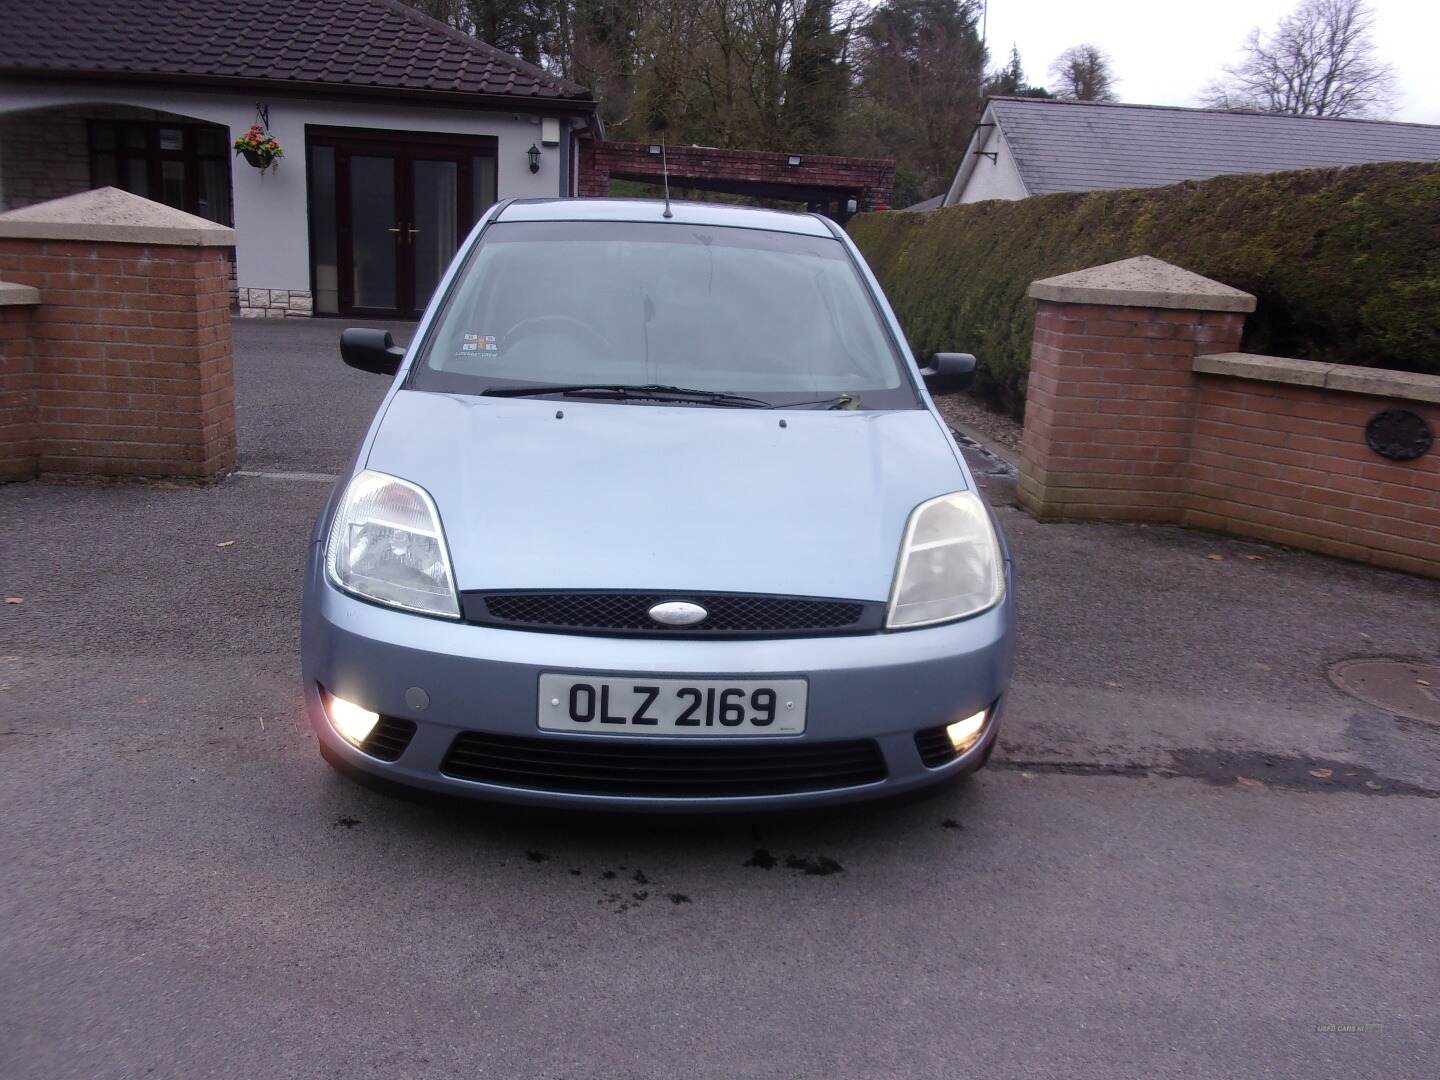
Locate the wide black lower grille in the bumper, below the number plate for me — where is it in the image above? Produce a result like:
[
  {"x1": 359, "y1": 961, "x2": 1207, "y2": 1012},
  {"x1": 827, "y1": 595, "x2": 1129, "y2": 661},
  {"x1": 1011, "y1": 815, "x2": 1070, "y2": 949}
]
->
[{"x1": 441, "y1": 732, "x2": 886, "y2": 799}]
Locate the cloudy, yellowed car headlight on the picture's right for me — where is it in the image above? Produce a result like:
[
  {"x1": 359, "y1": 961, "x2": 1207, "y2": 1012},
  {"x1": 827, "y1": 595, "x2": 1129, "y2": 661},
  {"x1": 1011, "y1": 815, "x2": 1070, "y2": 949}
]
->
[{"x1": 886, "y1": 491, "x2": 1005, "y2": 629}]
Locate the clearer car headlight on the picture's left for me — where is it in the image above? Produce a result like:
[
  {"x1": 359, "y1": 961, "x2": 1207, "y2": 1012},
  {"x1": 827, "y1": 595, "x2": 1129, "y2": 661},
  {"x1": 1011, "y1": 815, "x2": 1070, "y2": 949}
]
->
[{"x1": 325, "y1": 471, "x2": 459, "y2": 619}]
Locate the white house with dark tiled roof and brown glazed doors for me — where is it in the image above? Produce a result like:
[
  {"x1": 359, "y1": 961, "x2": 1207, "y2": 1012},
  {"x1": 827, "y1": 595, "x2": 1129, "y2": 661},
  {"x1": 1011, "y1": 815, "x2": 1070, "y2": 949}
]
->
[{"x1": 0, "y1": 0, "x2": 603, "y2": 317}]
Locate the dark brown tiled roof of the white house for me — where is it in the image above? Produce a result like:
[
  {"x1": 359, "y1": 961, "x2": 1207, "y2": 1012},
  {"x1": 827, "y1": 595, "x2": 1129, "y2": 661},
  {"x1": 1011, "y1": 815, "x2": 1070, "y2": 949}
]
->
[{"x1": 0, "y1": 0, "x2": 590, "y2": 101}]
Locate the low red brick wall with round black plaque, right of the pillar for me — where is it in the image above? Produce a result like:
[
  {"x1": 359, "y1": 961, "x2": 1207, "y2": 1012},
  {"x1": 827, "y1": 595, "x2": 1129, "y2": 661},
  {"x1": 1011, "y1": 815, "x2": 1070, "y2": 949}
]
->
[{"x1": 1182, "y1": 374, "x2": 1440, "y2": 577}]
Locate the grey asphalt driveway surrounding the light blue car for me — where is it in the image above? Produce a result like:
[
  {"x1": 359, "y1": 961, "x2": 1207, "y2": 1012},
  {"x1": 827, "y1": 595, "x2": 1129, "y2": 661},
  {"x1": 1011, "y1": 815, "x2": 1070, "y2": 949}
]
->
[{"x1": 0, "y1": 320, "x2": 1440, "y2": 1080}]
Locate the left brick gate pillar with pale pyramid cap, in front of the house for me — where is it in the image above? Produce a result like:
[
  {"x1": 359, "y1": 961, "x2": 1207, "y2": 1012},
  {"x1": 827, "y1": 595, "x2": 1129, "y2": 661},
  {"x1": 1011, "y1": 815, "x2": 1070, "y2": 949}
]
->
[{"x1": 0, "y1": 189, "x2": 235, "y2": 478}]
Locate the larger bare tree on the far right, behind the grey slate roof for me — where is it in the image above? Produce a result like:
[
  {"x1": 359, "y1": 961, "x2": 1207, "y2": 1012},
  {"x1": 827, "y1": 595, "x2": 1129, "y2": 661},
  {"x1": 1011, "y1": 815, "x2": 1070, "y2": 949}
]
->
[{"x1": 1200, "y1": 0, "x2": 1395, "y2": 117}]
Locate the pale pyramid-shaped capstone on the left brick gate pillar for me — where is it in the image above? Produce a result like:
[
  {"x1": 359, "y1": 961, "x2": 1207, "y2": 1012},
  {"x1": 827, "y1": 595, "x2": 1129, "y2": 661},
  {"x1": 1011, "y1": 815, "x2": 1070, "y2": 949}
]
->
[{"x1": 0, "y1": 187, "x2": 235, "y2": 248}]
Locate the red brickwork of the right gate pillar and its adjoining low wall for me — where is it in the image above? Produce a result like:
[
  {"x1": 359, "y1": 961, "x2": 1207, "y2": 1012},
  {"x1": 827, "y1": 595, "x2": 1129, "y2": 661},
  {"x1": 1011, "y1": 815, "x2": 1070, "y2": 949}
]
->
[{"x1": 1018, "y1": 292, "x2": 1440, "y2": 577}]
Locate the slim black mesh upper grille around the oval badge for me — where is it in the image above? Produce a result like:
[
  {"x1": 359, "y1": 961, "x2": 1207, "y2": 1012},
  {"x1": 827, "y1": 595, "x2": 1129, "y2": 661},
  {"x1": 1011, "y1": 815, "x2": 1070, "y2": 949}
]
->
[{"x1": 462, "y1": 592, "x2": 884, "y2": 638}]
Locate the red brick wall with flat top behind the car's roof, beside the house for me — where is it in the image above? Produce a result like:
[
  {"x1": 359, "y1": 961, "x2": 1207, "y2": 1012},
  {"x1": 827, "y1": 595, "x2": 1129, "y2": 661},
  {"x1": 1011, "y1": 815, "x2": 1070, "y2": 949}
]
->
[{"x1": 579, "y1": 141, "x2": 896, "y2": 210}]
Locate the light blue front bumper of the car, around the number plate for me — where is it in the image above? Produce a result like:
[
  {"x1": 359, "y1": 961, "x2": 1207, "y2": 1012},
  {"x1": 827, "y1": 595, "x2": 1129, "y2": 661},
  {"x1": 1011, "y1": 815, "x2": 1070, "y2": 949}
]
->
[{"x1": 302, "y1": 544, "x2": 1014, "y2": 812}]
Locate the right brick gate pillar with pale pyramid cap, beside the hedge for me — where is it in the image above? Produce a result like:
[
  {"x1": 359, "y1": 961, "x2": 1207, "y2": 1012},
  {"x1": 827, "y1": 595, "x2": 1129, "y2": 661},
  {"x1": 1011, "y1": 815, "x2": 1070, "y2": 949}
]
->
[{"x1": 1017, "y1": 256, "x2": 1254, "y2": 521}]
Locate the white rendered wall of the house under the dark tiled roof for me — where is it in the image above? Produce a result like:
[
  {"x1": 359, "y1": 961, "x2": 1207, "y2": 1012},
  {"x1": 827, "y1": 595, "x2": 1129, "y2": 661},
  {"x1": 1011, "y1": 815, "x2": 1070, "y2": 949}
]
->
[{"x1": 0, "y1": 82, "x2": 577, "y2": 291}]
